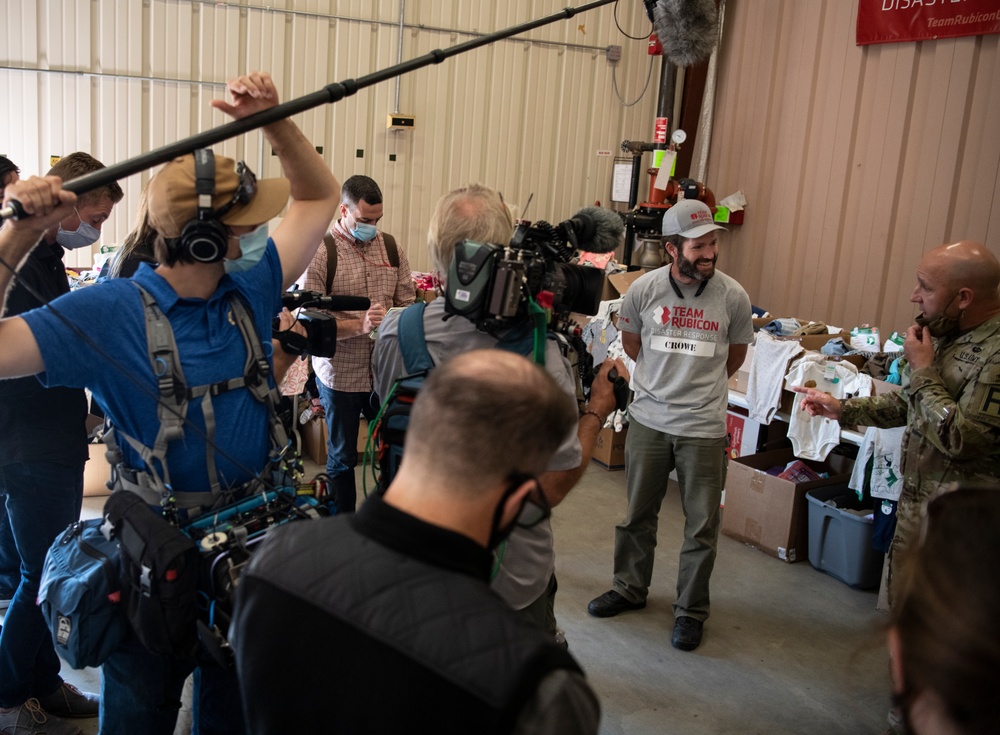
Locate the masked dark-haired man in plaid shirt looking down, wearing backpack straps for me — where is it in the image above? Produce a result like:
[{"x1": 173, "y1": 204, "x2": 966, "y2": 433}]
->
[{"x1": 305, "y1": 175, "x2": 414, "y2": 513}]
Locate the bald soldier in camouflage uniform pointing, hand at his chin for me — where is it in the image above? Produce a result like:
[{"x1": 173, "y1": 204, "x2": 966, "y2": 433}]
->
[{"x1": 795, "y1": 241, "x2": 1000, "y2": 605}]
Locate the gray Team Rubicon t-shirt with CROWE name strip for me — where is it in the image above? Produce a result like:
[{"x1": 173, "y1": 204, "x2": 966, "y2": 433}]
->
[{"x1": 618, "y1": 268, "x2": 753, "y2": 439}]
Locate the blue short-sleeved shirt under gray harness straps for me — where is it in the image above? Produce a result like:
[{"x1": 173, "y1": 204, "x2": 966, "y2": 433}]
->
[{"x1": 23, "y1": 240, "x2": 281, "y2": 492}]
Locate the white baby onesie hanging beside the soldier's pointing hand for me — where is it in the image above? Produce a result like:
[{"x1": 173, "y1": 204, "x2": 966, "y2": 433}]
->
[{"x1": 784, "y1": 352, "x2": 871, "y2": 461}]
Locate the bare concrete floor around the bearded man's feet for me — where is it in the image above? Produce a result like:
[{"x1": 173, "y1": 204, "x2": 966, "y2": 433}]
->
[{"x1": 11, "y1": 463, "x2": 889, "y2": 735}]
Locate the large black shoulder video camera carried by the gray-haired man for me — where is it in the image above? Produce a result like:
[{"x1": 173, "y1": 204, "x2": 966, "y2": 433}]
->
[{"x1": 445, "y1": 207, "x2": 624, "y2": 333}]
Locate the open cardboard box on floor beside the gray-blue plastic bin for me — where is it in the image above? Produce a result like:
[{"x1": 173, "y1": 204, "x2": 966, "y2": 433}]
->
[{"x1": 722, "y1": 448, "x2": 854, "y2": 564}]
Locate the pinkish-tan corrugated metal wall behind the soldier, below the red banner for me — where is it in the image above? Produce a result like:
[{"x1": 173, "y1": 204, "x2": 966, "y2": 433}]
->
[{"x1": 706, "y1": 0, "x2": 1000, "y2": 332}]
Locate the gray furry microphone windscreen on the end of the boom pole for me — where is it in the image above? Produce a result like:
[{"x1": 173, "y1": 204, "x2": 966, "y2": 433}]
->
[{"x1": 653, "y1": 0, "x2": 719, "y2": 66}]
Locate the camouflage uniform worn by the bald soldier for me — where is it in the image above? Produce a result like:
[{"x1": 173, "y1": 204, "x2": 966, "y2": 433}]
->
[{"x1": 840, "y1": 317, "x2": 1000, "y2": 604}]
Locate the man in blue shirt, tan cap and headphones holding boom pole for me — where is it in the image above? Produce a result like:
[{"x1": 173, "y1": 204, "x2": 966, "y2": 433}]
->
[{"x1": 0, "y1": 72, "x2": 339, "y2": 735}]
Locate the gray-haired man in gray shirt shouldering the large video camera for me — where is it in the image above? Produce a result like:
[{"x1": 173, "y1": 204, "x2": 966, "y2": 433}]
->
[{"x1": 372, "y1": 184, "x2": 628, "y2": 639}]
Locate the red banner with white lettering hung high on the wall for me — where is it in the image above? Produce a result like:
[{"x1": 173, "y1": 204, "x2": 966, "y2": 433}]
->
[{"x1": 858, "y1": 0, "x2": 1000, "y2": 46}]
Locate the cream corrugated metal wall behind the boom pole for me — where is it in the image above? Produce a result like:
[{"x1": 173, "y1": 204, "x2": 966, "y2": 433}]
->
[{"x1": 0, "y1": 0, "x2": 658, "y2": 270}]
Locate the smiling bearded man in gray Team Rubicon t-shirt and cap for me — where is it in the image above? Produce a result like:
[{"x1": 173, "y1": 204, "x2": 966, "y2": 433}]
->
[{"x1": 587, "y1": 199, "x2": 753, "y2": 651}]
